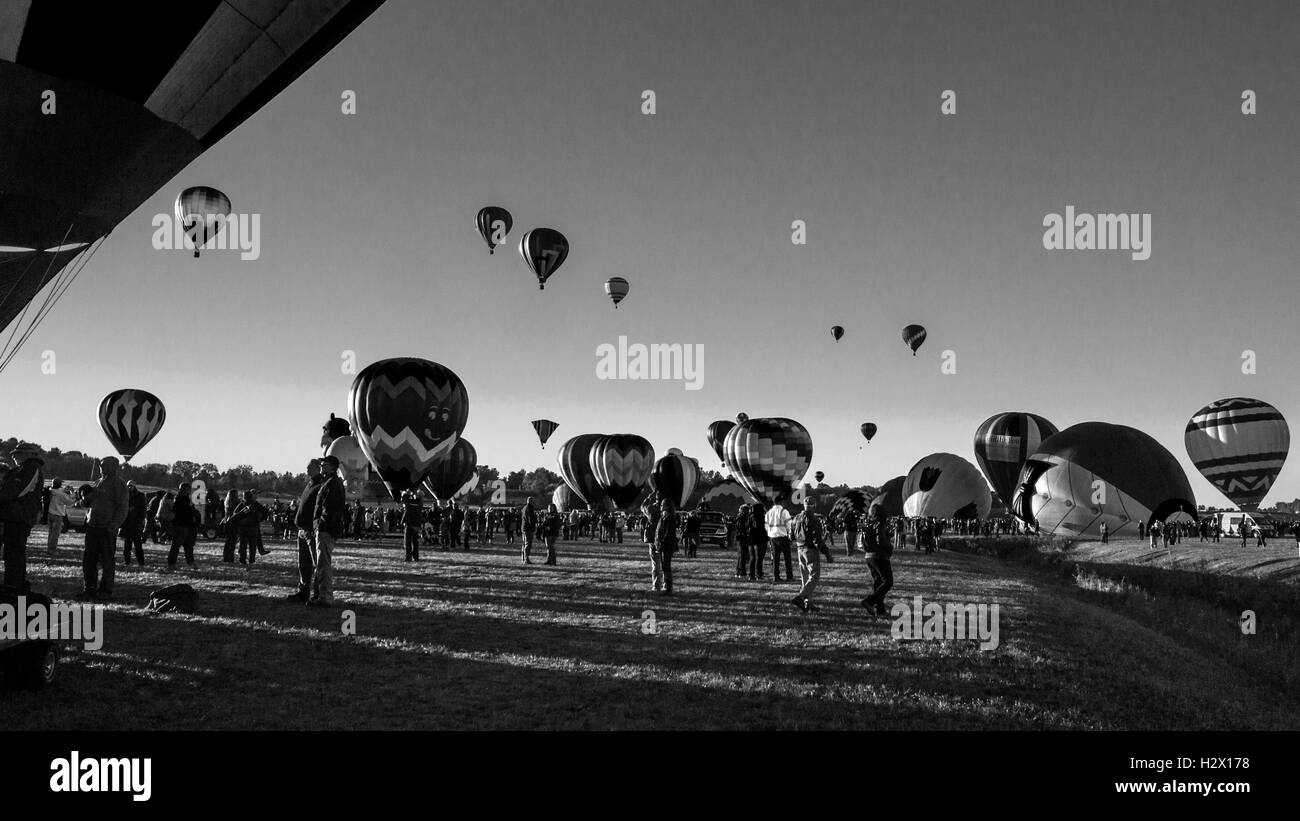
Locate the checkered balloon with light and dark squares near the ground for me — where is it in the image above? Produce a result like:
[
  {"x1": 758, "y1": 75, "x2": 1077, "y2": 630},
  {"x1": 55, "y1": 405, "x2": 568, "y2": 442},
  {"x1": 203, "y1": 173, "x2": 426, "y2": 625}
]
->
[{"x1": 723, "y1": 418, "x2": 813, "y2": 504}]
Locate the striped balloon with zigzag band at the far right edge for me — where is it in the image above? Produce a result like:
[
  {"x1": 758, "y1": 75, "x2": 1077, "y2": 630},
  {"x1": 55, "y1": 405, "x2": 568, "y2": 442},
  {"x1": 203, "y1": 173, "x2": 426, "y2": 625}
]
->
[{"x1": 1183, "y1": 396, "x2": 1291, "y2": 511}]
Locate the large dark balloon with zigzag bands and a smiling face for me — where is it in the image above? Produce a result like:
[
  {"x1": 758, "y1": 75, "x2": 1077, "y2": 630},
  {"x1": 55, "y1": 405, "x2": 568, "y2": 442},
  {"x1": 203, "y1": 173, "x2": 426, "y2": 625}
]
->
[{"x1": 347, "y1": 359, "x2": 469, "y2": 499}]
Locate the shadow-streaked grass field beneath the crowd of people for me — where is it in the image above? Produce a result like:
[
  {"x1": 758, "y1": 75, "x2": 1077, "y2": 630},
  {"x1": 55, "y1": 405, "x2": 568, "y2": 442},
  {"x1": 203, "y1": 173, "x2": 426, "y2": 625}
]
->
[{"x1": 0, "y1": 527, "x2": 1300, "y2": 730}]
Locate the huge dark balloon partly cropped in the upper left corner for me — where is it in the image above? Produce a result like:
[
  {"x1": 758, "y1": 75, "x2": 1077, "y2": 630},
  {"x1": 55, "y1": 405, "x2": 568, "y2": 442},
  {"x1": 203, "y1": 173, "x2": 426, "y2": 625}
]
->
[{"x1": 0, "y1": 0, "x2": 378, "y2": 366}]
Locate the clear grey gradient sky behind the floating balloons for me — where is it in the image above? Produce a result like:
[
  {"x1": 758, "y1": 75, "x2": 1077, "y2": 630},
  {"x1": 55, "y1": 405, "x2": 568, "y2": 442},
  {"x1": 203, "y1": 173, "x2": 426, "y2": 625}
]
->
[{"x1": 0, "y1": 0, "x2": 1300, "y2": 504}]
